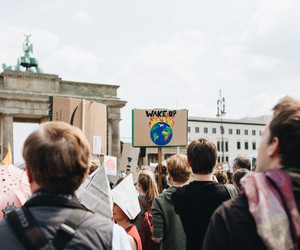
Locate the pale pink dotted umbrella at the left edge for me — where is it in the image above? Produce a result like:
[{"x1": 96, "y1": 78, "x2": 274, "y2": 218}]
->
[{"x1": 0, "y1": 164, "x2": 31, "y2": 219}]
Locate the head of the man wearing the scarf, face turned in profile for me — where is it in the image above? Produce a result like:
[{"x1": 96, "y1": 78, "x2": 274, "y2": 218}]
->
[{"x1": 256, "y1": 97, "x2": 300, "y2": 172}]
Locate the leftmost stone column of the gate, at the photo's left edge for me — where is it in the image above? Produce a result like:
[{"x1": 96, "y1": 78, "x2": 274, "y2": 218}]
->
[{"x1": 2, "y1": 115, "x2": 14, "y2": 162}]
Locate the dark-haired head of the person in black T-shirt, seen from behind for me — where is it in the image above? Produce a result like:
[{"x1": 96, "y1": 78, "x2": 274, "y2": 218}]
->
[{"x1": 187, "y1": 138, "x2": 217, "y2": 174}]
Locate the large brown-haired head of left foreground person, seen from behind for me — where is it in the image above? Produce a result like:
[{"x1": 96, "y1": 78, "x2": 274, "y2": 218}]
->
[{"x1": 23, "y1": 122, "x2": 91, "y2": 193}]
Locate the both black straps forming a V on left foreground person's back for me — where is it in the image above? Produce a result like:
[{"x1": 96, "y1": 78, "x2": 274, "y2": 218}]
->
[{"x1": 7, "y1": 207, "x2": 87, "y2": 250}]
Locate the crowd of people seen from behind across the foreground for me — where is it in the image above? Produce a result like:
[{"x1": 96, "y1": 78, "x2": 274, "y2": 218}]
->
[{"x1": 0, "y1": 97, "x2": 300, "y2": 250}]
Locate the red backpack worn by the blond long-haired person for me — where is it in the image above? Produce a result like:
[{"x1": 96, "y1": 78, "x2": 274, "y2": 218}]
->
[{"x1": 139, "y1": 199, "x2": 160, "y2": 250}]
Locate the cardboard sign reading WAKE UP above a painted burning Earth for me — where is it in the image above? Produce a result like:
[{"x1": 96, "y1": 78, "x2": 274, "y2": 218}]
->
[{"x1": 132, "y1": 109, "x2": 188, "y2": 147}]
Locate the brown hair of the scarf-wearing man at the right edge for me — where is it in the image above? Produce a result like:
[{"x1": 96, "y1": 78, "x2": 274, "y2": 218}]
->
[{"x1": 269, "y1": 97, "x2": 300, "y2": 167}]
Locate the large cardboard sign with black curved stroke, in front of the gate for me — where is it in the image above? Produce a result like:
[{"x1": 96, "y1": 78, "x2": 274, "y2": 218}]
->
[{"x1": 52, "y1": 96, "x2": 107, "y2": 154}]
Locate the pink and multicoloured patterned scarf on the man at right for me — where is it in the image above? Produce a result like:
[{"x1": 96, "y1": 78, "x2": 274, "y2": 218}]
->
[{"x1": 241, "y1": 169, "x2": 300, "y2": 249}]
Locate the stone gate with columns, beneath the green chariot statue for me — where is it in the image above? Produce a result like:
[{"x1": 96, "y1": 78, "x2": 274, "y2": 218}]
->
[{"x1": 0, "y1": 70, "x2": 126, "y2": 164}]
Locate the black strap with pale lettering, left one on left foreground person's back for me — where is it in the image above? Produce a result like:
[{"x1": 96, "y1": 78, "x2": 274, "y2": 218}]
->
[{"x1": 6, "y1": 207, "x2": 48, "y2": 250}]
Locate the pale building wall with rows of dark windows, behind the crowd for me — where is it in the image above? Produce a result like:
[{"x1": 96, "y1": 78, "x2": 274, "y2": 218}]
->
[{"x1": 188, "y1": 116, "x2": 268, "y2": 165}]
